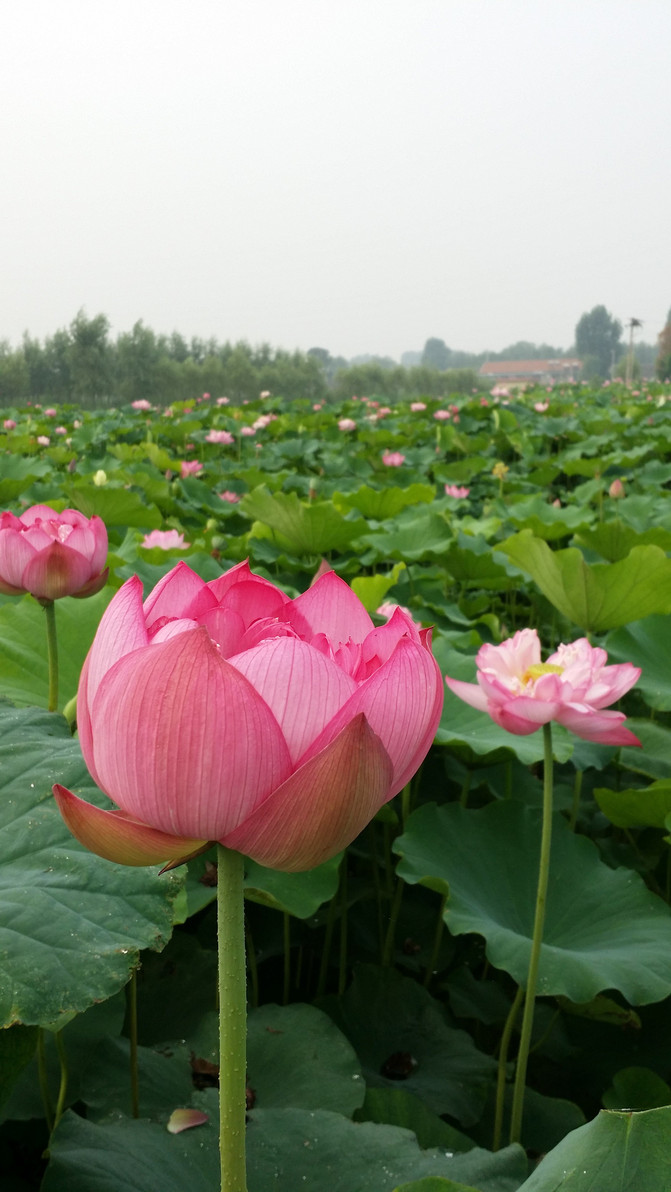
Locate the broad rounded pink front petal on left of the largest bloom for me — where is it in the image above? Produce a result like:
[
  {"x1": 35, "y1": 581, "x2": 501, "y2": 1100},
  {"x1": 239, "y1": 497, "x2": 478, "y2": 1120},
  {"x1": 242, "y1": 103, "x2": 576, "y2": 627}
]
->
[{"x1": 91, "y1": 628, "x2": 291, "y2": 840}]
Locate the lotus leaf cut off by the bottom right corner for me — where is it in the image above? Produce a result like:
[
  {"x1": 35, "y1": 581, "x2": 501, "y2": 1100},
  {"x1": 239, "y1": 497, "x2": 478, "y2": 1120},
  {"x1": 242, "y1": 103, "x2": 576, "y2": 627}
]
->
[{"x1": 520, "y1": 1105, "x2": 671, "y2": 1192}]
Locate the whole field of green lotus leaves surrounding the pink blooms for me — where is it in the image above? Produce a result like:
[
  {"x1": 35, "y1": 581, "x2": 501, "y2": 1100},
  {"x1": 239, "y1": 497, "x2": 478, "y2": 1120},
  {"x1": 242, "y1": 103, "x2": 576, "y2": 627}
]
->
[{"x1": 0, "y1": 384, "x2": 671, "y2": 1192}]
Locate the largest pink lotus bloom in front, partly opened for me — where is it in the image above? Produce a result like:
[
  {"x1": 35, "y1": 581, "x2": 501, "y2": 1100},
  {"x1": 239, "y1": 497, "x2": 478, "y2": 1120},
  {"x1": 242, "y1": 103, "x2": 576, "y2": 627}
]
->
[{"x1": 54, "y1": 563, "x2": 445, "y2": 871}]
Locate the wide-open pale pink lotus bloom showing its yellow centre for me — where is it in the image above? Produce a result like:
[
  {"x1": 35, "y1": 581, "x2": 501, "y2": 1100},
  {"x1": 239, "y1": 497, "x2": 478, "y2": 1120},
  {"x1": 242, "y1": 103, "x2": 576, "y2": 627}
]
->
[{"x1": 446, "y1": 629, "x2": 641, "y2": 745}]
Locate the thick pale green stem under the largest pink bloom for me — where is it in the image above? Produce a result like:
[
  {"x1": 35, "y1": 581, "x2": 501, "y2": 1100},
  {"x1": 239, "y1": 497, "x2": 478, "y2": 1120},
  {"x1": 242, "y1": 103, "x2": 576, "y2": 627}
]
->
[{"x1": 217, "y1": 844, "x2": 247, "y2": 1192}]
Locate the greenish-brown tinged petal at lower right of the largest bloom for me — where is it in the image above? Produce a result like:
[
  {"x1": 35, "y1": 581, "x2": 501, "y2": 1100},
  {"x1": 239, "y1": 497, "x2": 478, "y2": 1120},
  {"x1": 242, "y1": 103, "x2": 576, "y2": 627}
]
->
[{"x1": 222, "y1": 714, "x2": 392, "y2": 873}]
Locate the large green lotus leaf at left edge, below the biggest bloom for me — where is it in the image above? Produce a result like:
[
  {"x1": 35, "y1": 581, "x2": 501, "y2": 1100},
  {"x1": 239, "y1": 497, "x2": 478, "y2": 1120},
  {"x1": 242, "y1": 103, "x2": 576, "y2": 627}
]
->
[{"x1": 0, "y1": 707, "x2": 181, "y2": 1025}]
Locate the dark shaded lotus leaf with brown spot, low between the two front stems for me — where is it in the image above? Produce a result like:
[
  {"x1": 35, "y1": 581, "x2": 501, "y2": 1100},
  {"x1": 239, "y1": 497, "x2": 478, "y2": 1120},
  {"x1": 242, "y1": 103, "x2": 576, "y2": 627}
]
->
[{"x1": 323, "y1": 964, "x2": 495, "y2": 1126}]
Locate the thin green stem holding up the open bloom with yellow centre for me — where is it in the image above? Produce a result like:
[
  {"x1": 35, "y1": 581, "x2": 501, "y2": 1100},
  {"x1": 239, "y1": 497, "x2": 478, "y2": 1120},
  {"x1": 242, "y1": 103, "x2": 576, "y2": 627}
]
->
[{"x1": 510, "y1": 722, "x2": 553, "y2": 1142}]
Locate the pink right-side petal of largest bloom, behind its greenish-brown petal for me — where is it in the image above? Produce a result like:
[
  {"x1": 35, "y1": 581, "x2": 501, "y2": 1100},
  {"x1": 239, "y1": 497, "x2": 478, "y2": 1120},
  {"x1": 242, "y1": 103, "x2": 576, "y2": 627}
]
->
[{"x1": 302, "y1": 638, "x2": 443, "y2": 799}]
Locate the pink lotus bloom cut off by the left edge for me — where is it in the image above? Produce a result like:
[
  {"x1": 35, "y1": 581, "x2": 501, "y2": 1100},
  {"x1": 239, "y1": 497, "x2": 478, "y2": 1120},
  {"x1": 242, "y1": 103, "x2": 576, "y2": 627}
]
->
[{"x1": 0, "y1": 505, "x2": 107, "y2": 601}]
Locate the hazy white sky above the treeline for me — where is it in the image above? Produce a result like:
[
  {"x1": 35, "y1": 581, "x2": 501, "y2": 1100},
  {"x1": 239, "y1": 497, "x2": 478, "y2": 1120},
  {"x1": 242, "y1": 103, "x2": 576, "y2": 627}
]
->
[{"x1": 0, "y1": 0, "x2": 671, "y2": 358}]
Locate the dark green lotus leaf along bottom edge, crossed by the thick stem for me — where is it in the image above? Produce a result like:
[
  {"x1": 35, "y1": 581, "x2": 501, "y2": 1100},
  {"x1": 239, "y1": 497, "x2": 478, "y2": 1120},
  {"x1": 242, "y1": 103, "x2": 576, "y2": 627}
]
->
[{"x1": 42, "y1": 1098, "x2": 527, "y2": 1192}]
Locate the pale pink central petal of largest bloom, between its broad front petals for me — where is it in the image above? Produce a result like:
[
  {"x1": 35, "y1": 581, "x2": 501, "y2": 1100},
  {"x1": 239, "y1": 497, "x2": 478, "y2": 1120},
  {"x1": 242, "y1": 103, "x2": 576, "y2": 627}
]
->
[{"x1": 229, "y1": 637, "x2": 356, "y2": 764}]
